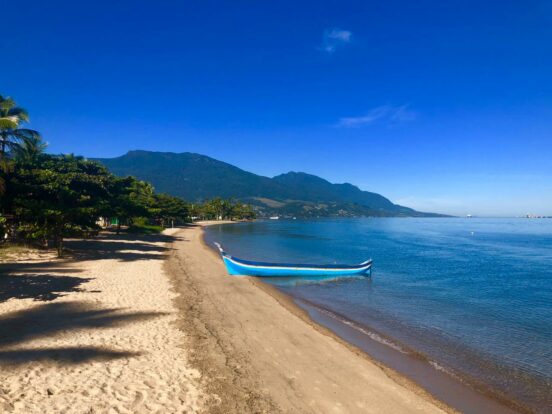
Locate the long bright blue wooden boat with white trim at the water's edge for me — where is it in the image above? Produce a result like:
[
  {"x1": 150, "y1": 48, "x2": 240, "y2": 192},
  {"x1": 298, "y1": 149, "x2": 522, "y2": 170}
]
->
[{"x1": 215, "y1": 243, "x2": 372, "y2": 277}]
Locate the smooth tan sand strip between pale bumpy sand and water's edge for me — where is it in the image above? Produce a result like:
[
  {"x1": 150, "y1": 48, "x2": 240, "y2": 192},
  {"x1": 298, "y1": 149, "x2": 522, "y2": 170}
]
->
[{"x1": 165, "y1": 223, "x2": 450, "y2": 413}]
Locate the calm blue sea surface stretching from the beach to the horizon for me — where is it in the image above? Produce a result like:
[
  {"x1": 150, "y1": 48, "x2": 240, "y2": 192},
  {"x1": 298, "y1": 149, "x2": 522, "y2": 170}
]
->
[{"x1": 206, "y1": 218, "x2": 552, "y2": 412}]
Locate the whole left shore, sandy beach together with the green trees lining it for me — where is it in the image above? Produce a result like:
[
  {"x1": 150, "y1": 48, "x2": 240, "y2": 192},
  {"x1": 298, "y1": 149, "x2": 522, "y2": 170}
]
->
[{"x1": 0, "y1": 94, "x2": 443, "y2": 414}]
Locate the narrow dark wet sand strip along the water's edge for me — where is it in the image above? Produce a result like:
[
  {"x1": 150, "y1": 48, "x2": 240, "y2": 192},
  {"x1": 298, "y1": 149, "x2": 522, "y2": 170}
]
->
[{"x1": 198, "y1": 222, "x2": 532, "y2": 414}]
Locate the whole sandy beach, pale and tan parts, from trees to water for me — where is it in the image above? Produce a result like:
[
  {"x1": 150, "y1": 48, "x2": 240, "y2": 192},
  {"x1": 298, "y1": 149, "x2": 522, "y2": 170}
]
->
[{"x1": 0, "y1": 226, "x2": 450, "y2": 413}]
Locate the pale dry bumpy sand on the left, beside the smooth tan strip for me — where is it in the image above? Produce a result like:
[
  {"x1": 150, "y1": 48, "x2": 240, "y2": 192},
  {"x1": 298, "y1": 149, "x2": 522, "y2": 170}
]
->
[{"x1": 0, "y1": 231, "x2": 202, "y2": 414}]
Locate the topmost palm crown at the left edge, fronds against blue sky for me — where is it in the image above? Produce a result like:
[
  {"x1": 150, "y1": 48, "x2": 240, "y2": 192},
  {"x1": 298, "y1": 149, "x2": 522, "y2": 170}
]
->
[{"x1": 0, "y1": 95, "x2": 40, "y2": 158}]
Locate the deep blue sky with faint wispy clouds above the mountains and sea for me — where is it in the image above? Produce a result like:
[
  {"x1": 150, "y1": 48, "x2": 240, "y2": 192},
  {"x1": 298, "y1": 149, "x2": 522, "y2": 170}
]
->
[{"x1": 4, "y1": 0, "x2": 552, "y2": 215}]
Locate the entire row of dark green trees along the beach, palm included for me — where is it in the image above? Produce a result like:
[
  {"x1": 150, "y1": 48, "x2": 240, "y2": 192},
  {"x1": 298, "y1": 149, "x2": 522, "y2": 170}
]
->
[{"x1": 0, "y1": 96, "x2": 255, "y2": 256}]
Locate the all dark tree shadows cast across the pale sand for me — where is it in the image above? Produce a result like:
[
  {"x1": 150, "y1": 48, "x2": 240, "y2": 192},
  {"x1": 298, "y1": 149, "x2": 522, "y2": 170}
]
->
[{"x1": 0, "y1": 233, "x2": 187, "y2": 371}]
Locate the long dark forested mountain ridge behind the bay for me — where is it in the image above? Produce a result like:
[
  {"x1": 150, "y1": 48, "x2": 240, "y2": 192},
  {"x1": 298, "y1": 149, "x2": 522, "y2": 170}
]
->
[{"x1": 96, "y1": 151, "x2": 439, "y2": 217}]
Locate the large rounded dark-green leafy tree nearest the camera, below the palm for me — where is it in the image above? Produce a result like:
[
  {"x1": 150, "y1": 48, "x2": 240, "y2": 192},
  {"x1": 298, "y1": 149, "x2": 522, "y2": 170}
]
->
[{"x1": 14, "y1": 155, "x2": 113, "y2": 256}]
